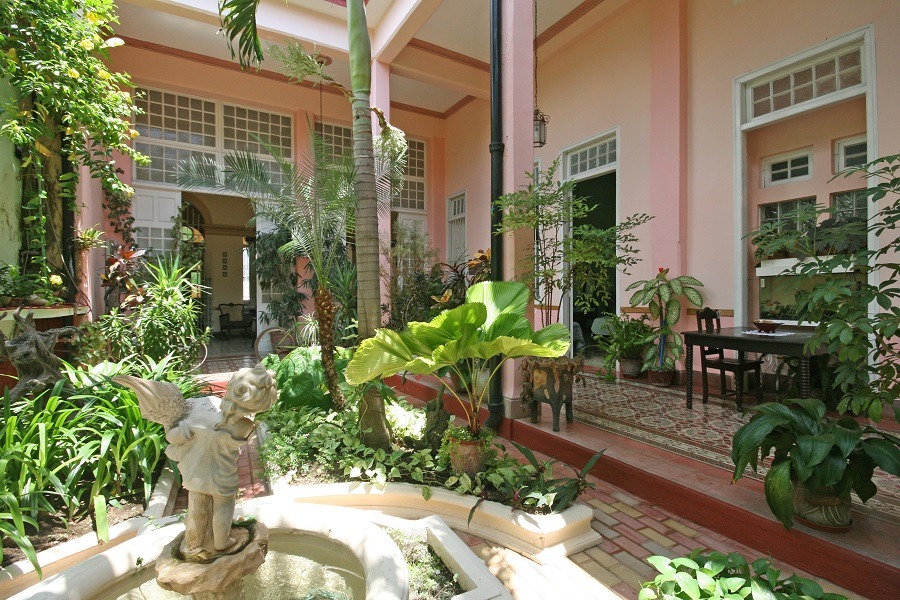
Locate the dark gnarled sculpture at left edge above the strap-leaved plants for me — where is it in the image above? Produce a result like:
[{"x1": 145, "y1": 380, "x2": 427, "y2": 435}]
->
[{"x1": 0, "y1": 307, "x2": 78, "y2": 402}]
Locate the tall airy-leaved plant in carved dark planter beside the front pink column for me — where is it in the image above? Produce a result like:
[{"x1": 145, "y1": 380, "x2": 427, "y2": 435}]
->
[{"x1": 498, "y1": 159, "x2": 651, "y2": 420}]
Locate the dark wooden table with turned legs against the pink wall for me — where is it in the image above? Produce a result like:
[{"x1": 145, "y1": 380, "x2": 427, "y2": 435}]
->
[{"x1": 681, "y1": 325, "x2": 827, "y2": 408}]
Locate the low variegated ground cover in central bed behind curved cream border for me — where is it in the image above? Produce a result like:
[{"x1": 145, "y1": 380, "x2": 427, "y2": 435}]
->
[{"x1": 261, "y1": 400, "x2": 602, "y2": 513}]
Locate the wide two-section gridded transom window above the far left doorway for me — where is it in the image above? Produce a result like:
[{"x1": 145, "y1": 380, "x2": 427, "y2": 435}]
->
[{"x1": 134, "y1": 89, "x2": 293, "y2": 185}]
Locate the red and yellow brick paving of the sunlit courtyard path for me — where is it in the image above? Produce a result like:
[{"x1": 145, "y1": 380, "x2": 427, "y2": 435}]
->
[{"x1": 195, "y1": 356, "x2": 865, "y2": 600}]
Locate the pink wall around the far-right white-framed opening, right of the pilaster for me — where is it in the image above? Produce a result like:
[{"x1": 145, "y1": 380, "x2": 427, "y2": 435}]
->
[{"x1": 687, "y1": 0, "x2": 900, "y2": 308}]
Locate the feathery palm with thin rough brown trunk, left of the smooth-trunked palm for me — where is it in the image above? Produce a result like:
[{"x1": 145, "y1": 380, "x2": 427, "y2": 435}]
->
[{"x1": 178, "y1": 135, "x2": 356, "y2": 408}]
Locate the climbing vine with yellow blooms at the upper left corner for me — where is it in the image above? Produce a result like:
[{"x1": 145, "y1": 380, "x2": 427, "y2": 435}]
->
[{"x1": 0, "y1": 0, "x2": 142, "y2": 282}]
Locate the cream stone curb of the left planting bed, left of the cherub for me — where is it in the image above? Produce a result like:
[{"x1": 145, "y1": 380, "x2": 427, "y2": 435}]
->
[{"x1": 0, "y1": 465, "x2": 179, "y2": 598}]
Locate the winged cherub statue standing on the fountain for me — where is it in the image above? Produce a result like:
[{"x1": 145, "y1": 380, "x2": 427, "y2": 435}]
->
[{"x1": 113, "y1": 364, "x2": 278, "y2": 562}]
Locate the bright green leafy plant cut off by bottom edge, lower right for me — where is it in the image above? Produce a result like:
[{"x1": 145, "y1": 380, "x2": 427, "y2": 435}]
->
[{"x1": 638, "y1": 548, "x2": 847, "y2": 600}]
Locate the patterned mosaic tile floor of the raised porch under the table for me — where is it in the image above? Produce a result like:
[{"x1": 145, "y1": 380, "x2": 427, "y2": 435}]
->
[{"x1": 574, "y1": 375, "x2": 900, "y2": 523}]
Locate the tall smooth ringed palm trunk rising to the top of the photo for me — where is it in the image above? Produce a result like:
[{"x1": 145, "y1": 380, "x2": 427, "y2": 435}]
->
[{"x1": 347, "y1": 0, "x2": 391, "y2": 449}]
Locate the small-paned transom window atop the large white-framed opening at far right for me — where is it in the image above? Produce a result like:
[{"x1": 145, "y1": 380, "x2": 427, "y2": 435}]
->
[{"x1": 748, "y1": 46, "x2": 863, "y2": 118}]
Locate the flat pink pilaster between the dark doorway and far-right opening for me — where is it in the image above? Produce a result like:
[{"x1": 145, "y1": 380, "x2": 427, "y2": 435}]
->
[{"x1": 650, "y1": 0, "x2": 687, "y2": 276}]
